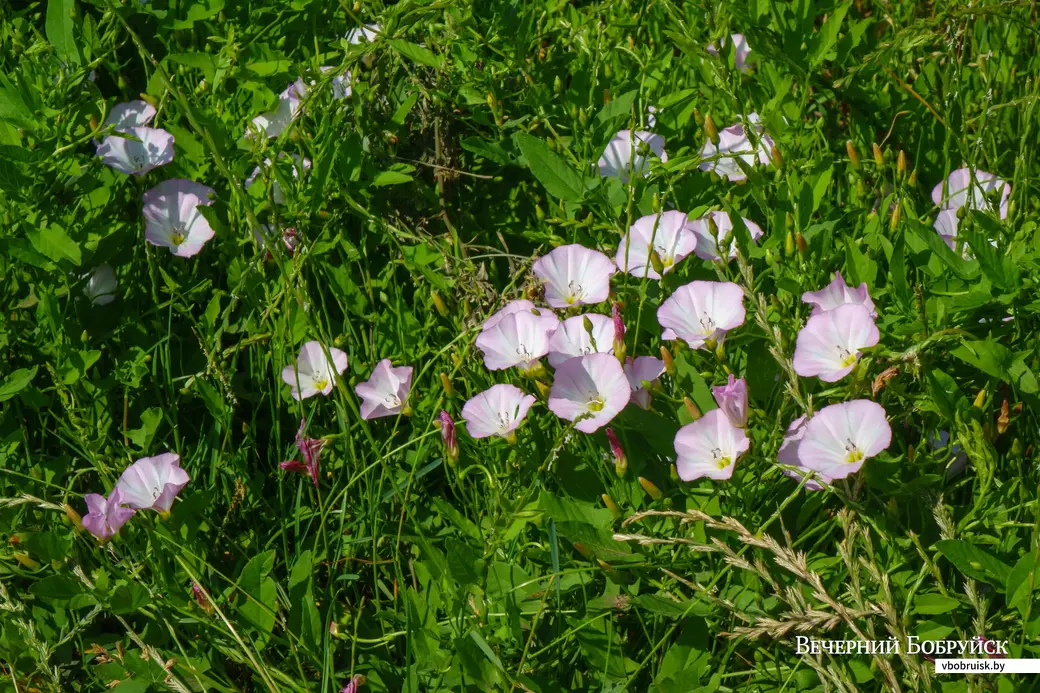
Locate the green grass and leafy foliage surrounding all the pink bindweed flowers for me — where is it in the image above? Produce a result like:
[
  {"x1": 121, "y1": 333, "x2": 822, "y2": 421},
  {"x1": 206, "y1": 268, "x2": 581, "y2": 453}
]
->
[{"x1": 0, "y1": 0, "x2": 1040, "y2": 693}]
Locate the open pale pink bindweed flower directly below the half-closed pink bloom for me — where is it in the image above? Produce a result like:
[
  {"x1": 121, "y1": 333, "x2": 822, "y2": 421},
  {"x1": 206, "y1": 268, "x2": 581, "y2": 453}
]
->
[{"x1": 675, "y1": 409, "x2": 751, "y2": 481}]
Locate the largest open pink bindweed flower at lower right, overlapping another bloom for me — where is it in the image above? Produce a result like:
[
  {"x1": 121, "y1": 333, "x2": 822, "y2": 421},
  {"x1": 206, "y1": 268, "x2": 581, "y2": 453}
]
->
[{"x1": 798, "y1": 400, "x2": 892, "y2": 479}]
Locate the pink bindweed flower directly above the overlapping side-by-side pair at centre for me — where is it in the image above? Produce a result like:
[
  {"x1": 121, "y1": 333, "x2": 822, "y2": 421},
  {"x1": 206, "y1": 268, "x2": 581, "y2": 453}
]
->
[{"x1": 531, "y1": 243, "x2": 618, "y2": 308}]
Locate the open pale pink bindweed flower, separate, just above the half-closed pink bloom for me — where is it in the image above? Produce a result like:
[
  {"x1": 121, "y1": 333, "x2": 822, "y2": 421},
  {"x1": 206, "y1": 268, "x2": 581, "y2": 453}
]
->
[{"x1": 657, "y1": 281, "x2": 746, "y2": 349}]
